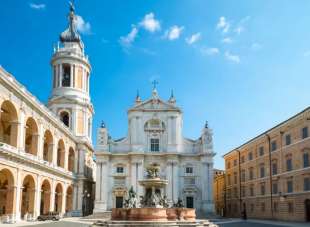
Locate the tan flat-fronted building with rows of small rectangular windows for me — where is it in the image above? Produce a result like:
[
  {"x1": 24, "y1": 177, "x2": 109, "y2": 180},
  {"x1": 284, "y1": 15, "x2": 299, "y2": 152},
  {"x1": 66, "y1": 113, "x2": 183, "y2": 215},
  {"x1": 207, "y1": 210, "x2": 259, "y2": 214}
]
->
[{"x1": 224, "y1": 107, "x2": 310, "y2": 221}]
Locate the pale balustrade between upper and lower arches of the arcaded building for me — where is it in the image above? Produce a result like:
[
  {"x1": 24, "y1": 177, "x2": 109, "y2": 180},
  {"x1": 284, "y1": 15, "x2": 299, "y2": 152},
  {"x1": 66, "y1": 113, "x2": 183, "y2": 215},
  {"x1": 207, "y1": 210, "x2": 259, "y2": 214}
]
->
[{"x1": 0, "y1": 142, "x2": 73, "y2": 176}]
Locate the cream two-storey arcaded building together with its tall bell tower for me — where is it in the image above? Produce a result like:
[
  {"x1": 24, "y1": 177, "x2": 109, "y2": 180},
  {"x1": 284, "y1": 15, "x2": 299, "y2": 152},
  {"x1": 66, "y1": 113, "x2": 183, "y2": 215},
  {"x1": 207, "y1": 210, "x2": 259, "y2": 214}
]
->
[{"x1": 0, "y1": 5, "x2": 95, "y2": 222}]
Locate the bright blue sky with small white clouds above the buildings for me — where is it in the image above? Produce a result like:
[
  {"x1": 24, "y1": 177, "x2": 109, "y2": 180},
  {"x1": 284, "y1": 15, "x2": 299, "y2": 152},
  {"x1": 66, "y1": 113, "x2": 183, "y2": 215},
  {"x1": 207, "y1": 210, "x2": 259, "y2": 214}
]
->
[{"x1": 0, "y1": 0, "x2": 310, "y2": 168}]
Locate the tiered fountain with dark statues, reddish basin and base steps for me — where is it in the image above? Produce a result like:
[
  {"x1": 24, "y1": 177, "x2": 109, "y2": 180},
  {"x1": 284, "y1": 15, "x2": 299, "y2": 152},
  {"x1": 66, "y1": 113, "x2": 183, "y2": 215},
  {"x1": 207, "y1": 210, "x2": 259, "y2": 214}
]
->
[{"x1": 94, "y1": 164, "x2": 214, "y2": 226}]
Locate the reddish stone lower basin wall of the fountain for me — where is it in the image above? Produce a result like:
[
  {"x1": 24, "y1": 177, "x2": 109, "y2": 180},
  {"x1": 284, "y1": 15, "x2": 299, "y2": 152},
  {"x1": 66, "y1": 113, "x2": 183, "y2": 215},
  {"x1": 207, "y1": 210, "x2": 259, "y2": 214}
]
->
[{"x1": 111, "y1": 207, "x2": 196, "y2": 221}]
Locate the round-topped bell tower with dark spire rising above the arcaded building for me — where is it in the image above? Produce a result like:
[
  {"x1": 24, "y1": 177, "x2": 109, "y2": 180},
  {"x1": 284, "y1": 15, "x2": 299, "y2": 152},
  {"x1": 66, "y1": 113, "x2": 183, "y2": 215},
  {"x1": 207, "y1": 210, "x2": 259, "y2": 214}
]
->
[{"x1": 48, "y1": 3, "x2": 94, "y2": 143}]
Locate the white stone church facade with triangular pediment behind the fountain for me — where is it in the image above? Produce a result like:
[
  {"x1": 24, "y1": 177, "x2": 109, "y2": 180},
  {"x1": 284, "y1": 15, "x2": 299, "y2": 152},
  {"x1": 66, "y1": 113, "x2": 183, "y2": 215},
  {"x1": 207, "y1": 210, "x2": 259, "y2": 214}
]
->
[{"x1": 94, "y1": 87, "x2": 214, "y2": 214}]
